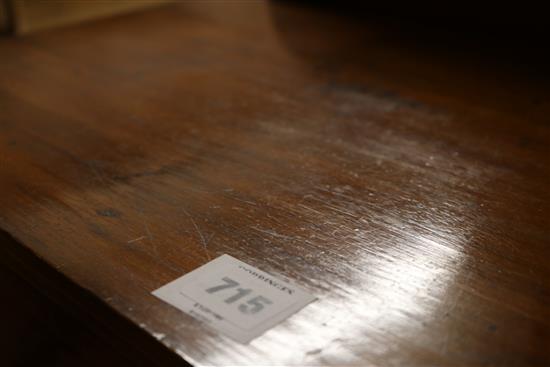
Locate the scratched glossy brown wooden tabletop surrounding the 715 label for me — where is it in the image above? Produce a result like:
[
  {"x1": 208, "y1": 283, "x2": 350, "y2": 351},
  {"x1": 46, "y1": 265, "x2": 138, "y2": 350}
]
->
[{"x1": 0, "y1": 2, "x2": 550, "y2": 366}]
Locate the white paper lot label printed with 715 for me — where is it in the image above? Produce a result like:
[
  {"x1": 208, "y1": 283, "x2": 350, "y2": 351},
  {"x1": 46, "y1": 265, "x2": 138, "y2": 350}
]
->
[{"x1": 153, "y1": 255, "x2": 315, "y2": 343}]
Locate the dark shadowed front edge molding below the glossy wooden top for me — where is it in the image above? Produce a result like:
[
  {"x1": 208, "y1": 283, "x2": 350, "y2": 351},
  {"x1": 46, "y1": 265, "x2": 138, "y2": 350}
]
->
[{"x1": 0, "y1": 229, "x2": 190, "y2": 367}]
